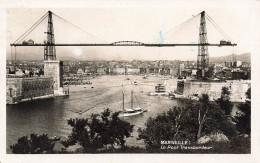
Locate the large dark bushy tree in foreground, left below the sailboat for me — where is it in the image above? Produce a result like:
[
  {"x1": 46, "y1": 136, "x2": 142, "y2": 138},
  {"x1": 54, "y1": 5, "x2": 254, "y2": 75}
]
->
[{"x1": 62, "y1": 109, "x2": 134, "y2": 152}]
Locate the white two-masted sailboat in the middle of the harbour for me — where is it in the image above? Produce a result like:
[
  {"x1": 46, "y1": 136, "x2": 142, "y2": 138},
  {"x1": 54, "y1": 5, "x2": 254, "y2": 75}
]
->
[{"x1": 119, "y1": 82, "x2": 147, "y2": 117}]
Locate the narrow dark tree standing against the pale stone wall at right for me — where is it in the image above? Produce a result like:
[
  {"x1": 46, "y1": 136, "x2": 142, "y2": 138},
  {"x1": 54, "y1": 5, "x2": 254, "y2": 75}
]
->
[{"x1": 216, "y1": 87, "x2": 233, "y2": 115}]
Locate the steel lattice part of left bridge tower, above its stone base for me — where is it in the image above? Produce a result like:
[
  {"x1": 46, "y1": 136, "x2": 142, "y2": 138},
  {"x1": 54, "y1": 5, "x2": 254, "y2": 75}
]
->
[{"x1": 44, "y1": 11, "x2": 56, "y2": 60}]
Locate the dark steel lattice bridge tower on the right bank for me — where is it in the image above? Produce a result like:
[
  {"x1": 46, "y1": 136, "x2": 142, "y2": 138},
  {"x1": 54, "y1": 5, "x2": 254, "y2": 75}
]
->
[{"x1": 197, "y1": 11, "x2": 209, "y2": 79}]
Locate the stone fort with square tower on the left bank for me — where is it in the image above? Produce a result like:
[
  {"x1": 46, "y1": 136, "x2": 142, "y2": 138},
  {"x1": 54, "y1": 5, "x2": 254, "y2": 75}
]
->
[{"x1": 6, "y1": 57, "x2": 69, "y2": 104}]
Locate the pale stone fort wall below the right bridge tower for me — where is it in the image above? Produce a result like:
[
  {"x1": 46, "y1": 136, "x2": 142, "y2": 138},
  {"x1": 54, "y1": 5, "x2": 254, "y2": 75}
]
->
[{"x1": 177, "y1": 80, "x2": 251, "y2": 102}]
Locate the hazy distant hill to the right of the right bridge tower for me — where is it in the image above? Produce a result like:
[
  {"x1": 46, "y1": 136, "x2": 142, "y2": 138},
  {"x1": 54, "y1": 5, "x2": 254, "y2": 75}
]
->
[{"x1": 209, "y1": 53, "x2": 251, "y2": 63}]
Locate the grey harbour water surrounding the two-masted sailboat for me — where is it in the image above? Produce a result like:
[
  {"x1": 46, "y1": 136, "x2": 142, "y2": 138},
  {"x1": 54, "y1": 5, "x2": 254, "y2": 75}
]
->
[{"x1": 6, "y1": 76, "x2": 183, "y2": 153}]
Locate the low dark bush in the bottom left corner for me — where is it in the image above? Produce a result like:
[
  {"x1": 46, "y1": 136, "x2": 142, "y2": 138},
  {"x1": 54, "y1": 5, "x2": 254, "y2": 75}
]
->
[{"x1": 10, "y1": 134, "x2": 55, "y2": 154}]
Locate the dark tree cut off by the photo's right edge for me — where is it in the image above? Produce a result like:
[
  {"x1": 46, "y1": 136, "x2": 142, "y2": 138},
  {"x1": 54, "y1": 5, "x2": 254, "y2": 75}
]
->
[{"x1": 234, "y1": 88, "x2": 251, "y2": 135}]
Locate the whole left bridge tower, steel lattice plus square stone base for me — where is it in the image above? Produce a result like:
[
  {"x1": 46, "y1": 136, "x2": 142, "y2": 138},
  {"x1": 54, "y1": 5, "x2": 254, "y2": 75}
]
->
[{"x1": 44, "y1": 11, "x2": 64, "y2": 95}]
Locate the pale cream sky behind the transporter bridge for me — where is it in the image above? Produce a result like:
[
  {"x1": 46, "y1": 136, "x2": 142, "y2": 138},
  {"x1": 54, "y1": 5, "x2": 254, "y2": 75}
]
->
[{"x1": 6, "y1": 1, "x2": 260, "y2": 60}]
